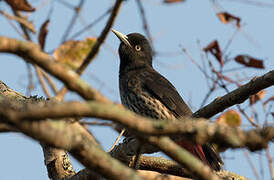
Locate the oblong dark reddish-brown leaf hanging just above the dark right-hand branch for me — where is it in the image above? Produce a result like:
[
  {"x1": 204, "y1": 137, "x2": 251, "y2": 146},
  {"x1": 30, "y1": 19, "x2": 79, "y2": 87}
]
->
[{"x1": 235, "y1": 55, "x2": 264, "y2": 69}]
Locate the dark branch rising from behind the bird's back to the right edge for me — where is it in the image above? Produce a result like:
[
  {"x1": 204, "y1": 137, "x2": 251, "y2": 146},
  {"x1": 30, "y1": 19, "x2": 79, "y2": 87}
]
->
[{"x1": 193, "y1": 70, "x2": 274, "y2": 118}]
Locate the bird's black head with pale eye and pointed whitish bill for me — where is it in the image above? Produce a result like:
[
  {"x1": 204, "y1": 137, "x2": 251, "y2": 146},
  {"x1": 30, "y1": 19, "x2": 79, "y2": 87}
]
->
[{"x1": 112, "y1": 30, "x2": 152, "y2": 73}]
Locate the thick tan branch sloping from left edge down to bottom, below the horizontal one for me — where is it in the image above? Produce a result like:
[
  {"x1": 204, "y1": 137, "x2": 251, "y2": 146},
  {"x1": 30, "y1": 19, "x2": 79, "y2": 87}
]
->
[{"x1": 1, "y1": 104, "x2": 141, "y2": 179}]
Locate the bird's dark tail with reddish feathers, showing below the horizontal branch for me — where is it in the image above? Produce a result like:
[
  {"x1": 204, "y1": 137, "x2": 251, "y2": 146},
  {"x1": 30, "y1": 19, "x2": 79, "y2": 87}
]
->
[{"x1": 176, "y1": 140, "x2": 222, "y2": 171}]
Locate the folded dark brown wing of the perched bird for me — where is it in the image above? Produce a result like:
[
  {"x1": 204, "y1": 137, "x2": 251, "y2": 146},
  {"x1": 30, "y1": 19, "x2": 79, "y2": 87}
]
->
[{"x1": 142, "y1": 71, "x2": 192, "y2": 118}]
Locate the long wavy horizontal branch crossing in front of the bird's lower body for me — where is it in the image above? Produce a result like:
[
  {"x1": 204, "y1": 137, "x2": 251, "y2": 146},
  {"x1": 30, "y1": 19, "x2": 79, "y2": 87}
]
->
[{"x1": 0, "y1": 102, "x2": 274, "y2": 150}]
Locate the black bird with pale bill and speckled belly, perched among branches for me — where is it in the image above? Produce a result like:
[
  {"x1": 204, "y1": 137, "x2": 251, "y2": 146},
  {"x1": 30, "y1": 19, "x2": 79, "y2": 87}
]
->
[{"x1": 112, "y1": 29, "x2": 223, "y2": 171}]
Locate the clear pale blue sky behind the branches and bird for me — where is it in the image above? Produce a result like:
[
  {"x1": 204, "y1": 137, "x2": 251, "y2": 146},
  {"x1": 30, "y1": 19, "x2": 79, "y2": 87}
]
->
[{"x1": 0, "y1": 0, "x2": 274, "y2": 180}]
